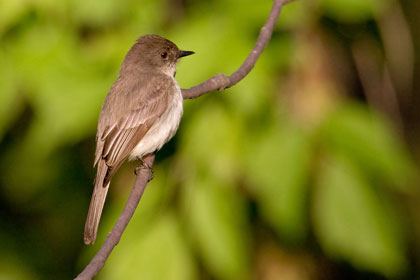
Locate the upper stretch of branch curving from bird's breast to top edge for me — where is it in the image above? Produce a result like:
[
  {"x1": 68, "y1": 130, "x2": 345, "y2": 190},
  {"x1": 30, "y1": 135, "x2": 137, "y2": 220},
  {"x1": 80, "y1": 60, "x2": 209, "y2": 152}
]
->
[{"x1": 182, "y1": 0, "x2": 293, "y2": 99}]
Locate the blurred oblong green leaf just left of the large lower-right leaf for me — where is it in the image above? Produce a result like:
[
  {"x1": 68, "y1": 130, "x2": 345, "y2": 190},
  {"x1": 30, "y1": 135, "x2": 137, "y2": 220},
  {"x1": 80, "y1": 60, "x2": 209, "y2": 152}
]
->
[{"x1": 247, "y1": 124, "x2": 312, "y2": 242}]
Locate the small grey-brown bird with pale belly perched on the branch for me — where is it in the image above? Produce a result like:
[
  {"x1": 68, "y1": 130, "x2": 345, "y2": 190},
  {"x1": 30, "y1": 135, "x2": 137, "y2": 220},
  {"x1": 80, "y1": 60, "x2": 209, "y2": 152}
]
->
[{"x1": 84, "y1": 35, "x2": 194, "y2": 244}]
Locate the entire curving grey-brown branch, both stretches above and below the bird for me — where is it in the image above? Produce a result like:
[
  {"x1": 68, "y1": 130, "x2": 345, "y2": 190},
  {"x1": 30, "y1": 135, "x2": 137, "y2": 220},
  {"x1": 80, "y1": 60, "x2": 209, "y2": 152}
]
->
[{"x1": 75, "y1": 0, "x2": 293, "y2": 280}]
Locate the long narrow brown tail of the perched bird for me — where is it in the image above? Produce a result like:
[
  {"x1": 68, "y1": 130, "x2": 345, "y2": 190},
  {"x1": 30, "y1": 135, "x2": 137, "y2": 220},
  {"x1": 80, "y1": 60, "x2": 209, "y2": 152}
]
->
[{"x1": 84, "y1": 160, "x2": 109, "y2": 245}]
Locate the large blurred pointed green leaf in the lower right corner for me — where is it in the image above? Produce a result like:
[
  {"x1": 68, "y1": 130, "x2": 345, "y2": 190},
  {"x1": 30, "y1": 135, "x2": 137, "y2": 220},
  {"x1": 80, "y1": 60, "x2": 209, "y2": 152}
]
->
[{"x1": 314, "y1": 154, "x2": 407, "y2": 276}]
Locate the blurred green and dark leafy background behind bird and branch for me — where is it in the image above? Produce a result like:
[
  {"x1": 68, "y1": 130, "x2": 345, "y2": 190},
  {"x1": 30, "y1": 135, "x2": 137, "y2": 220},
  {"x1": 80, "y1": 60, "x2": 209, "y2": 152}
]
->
[{"x1": 0, "y1": 0, "x2": 420, "y2": 280}]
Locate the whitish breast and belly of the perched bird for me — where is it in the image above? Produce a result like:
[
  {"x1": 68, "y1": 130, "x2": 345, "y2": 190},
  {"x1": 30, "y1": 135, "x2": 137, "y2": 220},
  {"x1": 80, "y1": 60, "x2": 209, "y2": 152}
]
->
[{"x1": 129, "y1": 79, "x2": 183, "y2": 160}]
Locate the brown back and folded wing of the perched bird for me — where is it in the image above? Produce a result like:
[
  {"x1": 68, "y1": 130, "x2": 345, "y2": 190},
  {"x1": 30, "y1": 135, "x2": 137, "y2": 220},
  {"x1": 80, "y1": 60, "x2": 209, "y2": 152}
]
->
[{"x1": 95, "y1": 74, "x2": 176, "y2": 185}]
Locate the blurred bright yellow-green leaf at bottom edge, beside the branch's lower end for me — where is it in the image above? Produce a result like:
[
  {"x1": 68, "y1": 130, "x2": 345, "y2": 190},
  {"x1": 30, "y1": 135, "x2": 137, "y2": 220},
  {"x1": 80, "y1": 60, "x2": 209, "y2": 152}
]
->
[{"x1": 100, "y1": 214, "x2": 197, "y2": 280}]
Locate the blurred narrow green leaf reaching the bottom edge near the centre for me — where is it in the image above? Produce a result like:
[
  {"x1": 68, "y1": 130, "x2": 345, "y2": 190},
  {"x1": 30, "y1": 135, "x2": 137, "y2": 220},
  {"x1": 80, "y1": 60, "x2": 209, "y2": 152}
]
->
[{"x1": 184, "y1": 176, "x2": 250, "y2": 279}]
